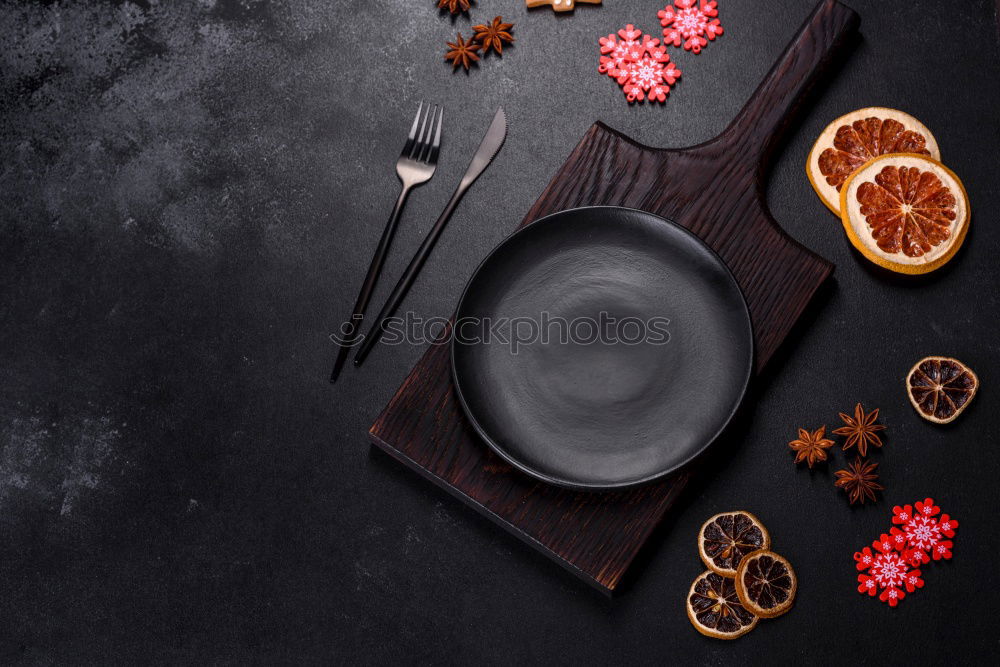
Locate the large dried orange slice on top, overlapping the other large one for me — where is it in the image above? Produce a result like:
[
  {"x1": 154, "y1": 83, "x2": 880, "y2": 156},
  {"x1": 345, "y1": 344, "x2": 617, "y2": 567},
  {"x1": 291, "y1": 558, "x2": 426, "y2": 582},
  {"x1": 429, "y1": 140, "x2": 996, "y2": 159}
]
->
[{"x1": 840, "y1": 153, "x2": 970, "y2": 273}]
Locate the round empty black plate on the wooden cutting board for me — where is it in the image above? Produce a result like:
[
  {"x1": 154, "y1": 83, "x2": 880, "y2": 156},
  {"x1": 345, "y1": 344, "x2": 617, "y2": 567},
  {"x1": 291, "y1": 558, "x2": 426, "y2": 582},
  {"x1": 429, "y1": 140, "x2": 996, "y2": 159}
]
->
[{"x1": 452, "y1": 207, "x2": 753, "y2": 490}]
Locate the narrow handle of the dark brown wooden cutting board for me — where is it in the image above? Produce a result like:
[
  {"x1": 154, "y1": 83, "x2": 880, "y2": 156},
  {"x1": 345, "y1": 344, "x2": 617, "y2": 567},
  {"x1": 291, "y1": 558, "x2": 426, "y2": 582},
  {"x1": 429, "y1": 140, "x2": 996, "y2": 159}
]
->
[{"x1": 719, "y1": 0, "x2": 860, "y2": 170}]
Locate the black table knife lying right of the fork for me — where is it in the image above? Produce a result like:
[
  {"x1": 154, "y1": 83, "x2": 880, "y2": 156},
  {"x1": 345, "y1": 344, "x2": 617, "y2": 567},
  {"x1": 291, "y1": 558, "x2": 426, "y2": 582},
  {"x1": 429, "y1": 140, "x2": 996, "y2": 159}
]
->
[{"x1": 354, "y1": 107, "x2": 507, "y2": 366}]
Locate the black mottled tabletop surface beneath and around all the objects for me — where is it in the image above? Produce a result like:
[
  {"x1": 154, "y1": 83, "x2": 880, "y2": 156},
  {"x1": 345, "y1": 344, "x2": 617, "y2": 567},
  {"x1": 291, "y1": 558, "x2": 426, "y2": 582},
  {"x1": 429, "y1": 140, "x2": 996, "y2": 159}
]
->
[{"x1": 0, "y1": 0, "x2": 1000, "y2": 664}]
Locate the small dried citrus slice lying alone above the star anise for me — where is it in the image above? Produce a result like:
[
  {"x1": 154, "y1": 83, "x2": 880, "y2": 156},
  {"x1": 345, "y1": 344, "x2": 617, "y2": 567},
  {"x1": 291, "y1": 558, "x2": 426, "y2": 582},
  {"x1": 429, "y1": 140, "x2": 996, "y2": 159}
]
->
[{"x1": 906, "y1": 357, "x2": 979, "y2": 424}]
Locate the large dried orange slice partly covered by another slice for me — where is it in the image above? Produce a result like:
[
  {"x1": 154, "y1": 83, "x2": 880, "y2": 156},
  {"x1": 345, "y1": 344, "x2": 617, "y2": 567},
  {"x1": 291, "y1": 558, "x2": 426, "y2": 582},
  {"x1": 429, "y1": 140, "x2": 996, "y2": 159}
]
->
[{"x1": 806, "y1": 107, "x2": 941, "y2": 215}]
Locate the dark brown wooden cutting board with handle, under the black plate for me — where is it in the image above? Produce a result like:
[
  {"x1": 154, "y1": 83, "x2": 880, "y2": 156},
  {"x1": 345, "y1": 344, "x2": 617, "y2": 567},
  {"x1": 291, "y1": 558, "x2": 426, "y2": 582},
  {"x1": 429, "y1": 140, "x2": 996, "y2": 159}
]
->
[{"x1": 369, "y1": 0, "x2": 859, "y2": 594}]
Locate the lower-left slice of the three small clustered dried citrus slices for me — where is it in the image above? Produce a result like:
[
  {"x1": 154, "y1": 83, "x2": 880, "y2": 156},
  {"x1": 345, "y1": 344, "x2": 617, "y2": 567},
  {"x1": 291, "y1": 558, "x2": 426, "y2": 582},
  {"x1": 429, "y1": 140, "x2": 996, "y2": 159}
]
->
[{"x1": 685, "y1": 570, "x2": 757, "y2": 639}]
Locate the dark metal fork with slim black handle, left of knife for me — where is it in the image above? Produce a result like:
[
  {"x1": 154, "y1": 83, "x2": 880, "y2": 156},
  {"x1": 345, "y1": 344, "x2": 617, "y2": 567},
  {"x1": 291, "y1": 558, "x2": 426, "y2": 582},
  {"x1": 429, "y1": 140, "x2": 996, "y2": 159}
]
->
[{"x1": 330, "y1": 102, "x2": 444, "y2": 384}]
